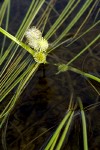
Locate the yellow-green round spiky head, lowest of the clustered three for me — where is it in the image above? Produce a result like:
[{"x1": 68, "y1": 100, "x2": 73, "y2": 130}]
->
[{"x1": 34, "y1": 52, "x2": 46, "y2": 63}]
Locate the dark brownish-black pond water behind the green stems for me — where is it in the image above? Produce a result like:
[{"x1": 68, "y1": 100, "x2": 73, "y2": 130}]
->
[{"x1": 0, "y1": 0, "x2": 100, "y2": 150}]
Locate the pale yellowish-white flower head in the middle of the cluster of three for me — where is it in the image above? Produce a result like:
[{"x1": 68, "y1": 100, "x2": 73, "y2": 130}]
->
[{"x1": 38, "y1": 37, "x2": 49, "y2": 52}]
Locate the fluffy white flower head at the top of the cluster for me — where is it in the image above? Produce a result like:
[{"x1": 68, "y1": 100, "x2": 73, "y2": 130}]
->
[{"x1": 25, "y1": 26, "x2": 42, "y2": 41}]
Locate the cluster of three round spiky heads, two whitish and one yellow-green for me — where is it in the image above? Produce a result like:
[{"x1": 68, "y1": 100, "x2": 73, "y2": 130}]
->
[{"x1": 25, "y1": 27, "x2": 49, "y2": 63}]
